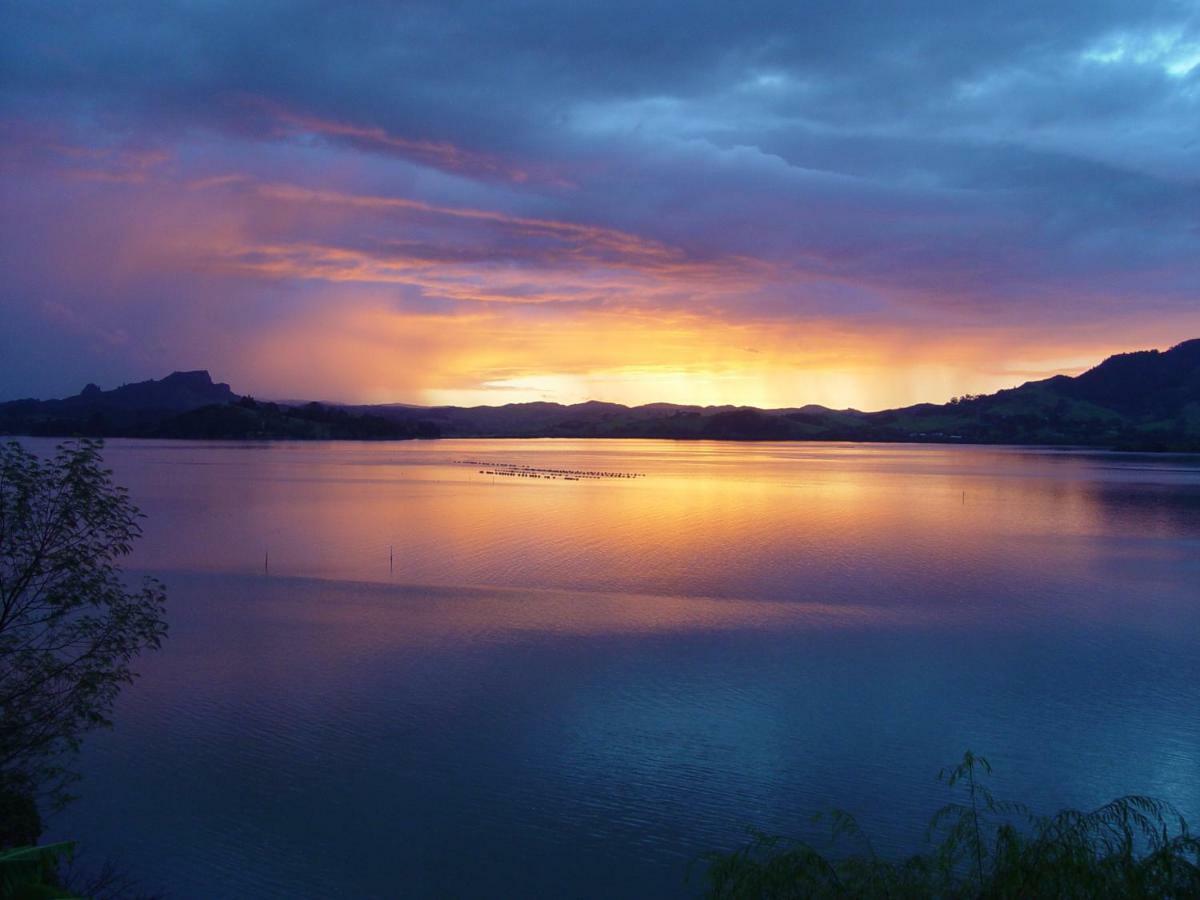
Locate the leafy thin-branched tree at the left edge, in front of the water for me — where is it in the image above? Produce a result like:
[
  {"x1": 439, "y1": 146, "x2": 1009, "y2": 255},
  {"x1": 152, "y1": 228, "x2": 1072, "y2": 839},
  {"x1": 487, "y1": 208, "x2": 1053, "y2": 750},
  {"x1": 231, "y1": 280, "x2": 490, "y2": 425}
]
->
[{"x1": 0, "y1": 440, "x2": 167, "y2": 820}]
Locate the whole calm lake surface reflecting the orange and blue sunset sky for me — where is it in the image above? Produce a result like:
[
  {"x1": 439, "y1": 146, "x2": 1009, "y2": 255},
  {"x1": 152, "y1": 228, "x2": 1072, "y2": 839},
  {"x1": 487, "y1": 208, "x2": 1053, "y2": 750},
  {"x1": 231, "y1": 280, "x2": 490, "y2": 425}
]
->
[{"x1": 25, "y1": 440, "x2": 1200, "y2": 898}]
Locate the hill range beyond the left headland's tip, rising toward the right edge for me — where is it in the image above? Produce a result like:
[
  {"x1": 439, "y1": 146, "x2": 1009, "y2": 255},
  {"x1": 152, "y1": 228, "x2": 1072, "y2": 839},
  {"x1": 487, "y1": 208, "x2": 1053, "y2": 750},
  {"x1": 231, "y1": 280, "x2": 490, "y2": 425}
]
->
[{"x1": 354, "y1": 340, "x2": 1200, "y2": 451}]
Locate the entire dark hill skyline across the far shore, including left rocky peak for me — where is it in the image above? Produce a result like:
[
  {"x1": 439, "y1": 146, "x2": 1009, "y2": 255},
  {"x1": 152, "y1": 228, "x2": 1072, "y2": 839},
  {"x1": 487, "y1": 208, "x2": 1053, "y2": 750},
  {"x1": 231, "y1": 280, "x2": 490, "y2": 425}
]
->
[{"x1": 7, "y1": 340, "x2": 1200, "y2": 452}]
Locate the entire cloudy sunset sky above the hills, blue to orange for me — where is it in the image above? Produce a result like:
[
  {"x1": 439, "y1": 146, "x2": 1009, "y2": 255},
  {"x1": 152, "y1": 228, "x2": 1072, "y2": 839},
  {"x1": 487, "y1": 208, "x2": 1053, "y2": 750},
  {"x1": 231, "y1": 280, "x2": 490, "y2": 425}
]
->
[{"x1": 0, "y1": 0, "x2": 1200, "y2": 409}]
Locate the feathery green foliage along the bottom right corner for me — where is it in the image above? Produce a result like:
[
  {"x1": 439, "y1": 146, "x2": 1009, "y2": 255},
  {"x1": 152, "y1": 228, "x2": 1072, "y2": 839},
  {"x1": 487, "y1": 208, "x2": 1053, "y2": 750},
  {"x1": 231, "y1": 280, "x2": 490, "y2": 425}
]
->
[{"x1": 704, "y1": 751, "x2": 1200, "y2": 900}]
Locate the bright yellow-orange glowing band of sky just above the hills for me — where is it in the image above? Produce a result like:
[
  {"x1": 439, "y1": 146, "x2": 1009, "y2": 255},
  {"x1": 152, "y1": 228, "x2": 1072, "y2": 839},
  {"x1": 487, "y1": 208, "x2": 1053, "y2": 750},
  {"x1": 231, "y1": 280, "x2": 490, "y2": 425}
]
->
[{"x1": 241, "y1": 300, "x2": 1190, "y2": 409}]
